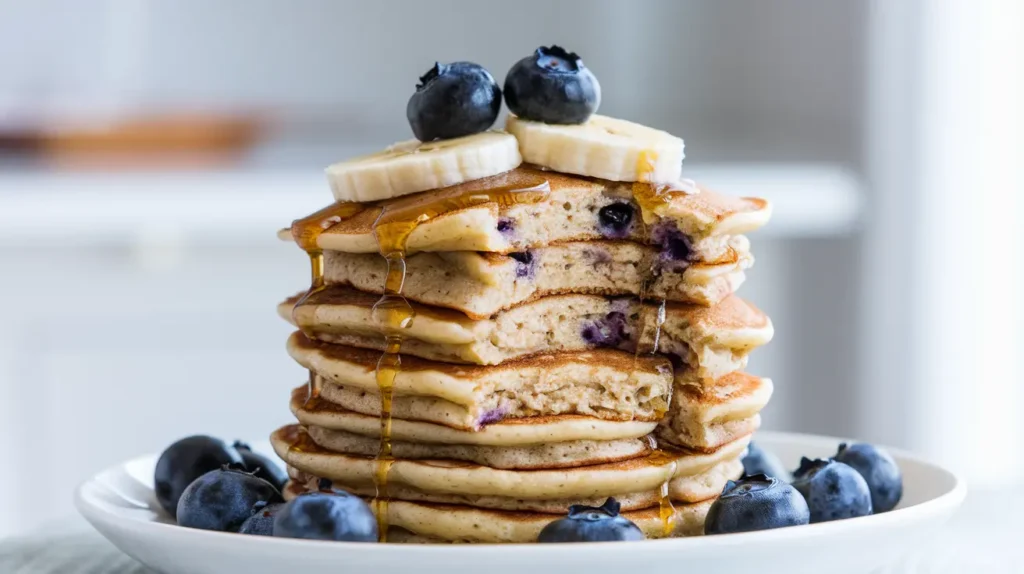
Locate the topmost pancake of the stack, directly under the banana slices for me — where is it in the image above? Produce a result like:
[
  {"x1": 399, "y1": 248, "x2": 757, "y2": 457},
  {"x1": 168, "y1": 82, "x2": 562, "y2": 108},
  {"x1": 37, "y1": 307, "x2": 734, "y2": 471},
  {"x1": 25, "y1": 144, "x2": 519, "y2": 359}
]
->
[{"x1": 282, "y1": 168, "x2": 771, "y2": 254}]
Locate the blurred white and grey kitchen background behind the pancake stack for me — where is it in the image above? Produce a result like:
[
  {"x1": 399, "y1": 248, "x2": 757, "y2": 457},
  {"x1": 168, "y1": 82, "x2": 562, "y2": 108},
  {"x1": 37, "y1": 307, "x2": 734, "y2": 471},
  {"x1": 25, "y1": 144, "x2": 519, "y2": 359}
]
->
[{"x1": 0, "y1": 0, "x2": 1024, "y2": 535}]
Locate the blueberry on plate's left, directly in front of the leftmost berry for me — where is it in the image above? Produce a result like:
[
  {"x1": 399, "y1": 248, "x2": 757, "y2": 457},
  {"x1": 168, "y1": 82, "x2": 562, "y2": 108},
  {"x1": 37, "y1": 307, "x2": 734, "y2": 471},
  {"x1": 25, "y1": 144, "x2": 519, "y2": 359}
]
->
[{"x1": 177, "y1": 465, "x2": 284, "y2": 532}]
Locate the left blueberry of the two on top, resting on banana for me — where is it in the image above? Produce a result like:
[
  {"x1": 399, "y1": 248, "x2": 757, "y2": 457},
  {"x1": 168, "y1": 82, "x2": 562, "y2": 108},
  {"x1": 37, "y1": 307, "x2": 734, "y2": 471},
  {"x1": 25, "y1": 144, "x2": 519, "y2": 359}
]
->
[{"x1": 406, "y1": 61, "x2": 502, "y2": 141}]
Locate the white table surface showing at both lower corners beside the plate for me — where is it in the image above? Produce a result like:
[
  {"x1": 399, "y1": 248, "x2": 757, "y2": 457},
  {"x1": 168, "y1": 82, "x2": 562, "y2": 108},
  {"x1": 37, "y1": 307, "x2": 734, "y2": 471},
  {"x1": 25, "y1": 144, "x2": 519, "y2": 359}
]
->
[{"x1": 0, "y1": 492, "x2": 1024, "y2": 574}]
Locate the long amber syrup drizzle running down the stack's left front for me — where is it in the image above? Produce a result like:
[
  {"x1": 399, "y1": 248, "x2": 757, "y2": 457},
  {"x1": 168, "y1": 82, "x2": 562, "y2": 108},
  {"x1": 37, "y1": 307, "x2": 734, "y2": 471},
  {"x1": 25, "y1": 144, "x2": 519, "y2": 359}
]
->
[{"x1": 373, "y1": 174, "x2": 550, "y2": 542}]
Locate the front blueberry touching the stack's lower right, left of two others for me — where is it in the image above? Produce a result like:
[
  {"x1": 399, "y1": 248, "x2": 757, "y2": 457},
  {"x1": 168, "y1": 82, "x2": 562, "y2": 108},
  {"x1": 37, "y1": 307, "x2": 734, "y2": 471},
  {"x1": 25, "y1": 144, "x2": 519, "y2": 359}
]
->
[{"x1": 705, "y1": 475, "x2": 811, "y2": 534}]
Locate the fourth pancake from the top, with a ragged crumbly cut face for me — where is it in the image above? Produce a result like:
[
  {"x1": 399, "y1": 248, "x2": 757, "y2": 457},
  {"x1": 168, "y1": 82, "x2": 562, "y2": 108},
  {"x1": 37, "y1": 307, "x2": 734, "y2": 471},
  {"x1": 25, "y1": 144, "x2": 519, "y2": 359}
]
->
[{"x1": 288, "y1": 333, "x2": 673, "y2": 429}]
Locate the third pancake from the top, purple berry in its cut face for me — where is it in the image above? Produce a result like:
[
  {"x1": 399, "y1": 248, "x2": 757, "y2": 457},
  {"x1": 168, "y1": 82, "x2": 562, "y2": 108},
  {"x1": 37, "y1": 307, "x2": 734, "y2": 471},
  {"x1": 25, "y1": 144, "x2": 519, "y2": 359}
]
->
[{"x1": 279, "y1": 285, "x2": 773, "y2": 379}]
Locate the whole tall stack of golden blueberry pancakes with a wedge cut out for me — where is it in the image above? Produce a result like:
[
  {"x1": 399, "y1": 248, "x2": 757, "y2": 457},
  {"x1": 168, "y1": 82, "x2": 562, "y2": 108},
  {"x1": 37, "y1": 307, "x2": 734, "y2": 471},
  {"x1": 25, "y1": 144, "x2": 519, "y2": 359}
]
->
[{"x1": 271, "y1": 167, "x2": 772, "y2": 542}]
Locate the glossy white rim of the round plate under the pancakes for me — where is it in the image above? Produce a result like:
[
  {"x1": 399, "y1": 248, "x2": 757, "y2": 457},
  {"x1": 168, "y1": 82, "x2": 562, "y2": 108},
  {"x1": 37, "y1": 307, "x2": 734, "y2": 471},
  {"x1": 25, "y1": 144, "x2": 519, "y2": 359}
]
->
[{"x1": 74, "y1": 431, "x2": 967, "y2": 556}]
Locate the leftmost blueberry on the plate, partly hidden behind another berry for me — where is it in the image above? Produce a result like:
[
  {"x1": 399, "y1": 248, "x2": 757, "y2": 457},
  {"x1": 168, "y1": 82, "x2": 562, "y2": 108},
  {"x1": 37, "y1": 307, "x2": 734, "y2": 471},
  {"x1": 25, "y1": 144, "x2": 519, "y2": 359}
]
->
[{"x1": 153, "y1": 435, "x2": 242, "y2": 518}]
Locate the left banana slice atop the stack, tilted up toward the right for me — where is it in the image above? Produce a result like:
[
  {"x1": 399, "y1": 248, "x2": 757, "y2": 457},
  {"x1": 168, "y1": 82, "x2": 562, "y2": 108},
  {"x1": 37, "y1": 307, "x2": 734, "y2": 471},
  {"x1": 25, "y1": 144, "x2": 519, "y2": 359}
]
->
[{"x1": 327, "y1": 131, "x2": 522, "y2": 203}]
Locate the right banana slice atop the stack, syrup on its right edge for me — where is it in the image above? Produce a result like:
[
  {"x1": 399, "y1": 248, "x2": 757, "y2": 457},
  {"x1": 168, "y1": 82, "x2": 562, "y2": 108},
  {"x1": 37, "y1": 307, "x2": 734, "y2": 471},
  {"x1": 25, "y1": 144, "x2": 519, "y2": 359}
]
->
[{"x1": 505, "y1": 115, "x2": 683, "y2": 183}]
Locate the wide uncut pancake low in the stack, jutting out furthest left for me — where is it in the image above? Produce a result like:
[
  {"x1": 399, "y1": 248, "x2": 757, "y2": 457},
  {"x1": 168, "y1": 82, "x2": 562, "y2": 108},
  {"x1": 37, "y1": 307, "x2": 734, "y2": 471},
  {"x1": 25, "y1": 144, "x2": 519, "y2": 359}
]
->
[{"x1": 270, "y1": 426, "x2": 750, "y2": 500}]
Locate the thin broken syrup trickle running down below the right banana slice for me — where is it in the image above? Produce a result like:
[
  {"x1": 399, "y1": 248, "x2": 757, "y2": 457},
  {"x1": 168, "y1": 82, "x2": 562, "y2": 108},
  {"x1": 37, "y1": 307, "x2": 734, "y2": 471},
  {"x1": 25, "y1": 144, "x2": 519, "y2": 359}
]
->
[{"x1": 633, "y1": 150, "x2": 686, "y2": 537}]
